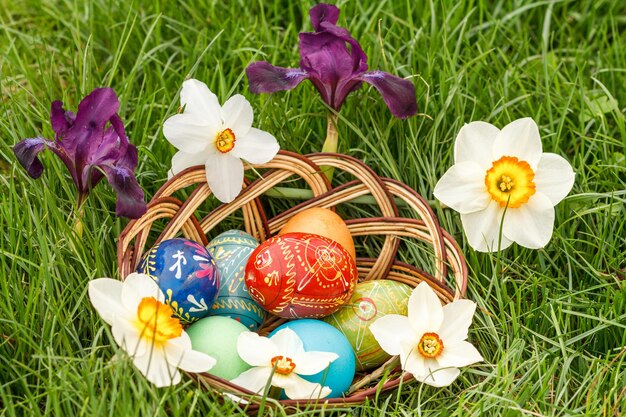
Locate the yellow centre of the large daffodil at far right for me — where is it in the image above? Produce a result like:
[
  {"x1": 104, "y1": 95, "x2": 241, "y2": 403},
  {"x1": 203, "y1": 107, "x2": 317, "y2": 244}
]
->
[{"x1": 485, "y1": 156, "x2": 535, "y2": 208}]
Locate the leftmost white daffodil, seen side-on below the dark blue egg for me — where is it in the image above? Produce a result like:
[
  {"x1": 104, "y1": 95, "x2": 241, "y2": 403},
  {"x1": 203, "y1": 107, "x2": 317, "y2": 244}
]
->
[{"x1": 89, "y1": 273, "x2": 215, "y2": 387}]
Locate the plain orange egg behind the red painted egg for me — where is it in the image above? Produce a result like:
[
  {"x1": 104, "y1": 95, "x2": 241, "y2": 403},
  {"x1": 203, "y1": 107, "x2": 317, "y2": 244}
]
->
[{"x1": 279, "y1": 207, "x2": 356, "y2": 259}]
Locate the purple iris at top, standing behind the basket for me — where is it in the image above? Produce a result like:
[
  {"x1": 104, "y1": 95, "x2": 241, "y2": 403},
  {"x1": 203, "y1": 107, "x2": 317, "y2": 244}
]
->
[{"x1": 246, "y1": 4, "x2": 417, "y2": 118}]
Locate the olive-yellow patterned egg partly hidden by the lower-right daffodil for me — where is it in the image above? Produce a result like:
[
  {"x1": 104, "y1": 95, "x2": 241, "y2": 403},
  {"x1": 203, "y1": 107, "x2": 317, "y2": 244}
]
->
[{"x1": 324, "y1": 280, "x2": 412, "y2": 371}]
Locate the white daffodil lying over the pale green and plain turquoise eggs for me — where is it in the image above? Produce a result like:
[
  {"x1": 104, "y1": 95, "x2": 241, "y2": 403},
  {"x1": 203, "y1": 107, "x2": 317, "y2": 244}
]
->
[{"x1": 231, "y1": 328, "x2": 338, "y2": 399}]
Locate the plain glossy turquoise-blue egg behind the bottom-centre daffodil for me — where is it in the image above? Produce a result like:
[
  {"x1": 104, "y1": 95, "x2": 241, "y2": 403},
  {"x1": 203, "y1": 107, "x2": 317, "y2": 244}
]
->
[{"x1": 269, "y1": 319, "x2": 356, "y2": 398}]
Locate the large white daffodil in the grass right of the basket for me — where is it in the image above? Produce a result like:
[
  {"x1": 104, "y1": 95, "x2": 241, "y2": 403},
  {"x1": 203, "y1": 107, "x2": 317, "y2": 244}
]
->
[{"x1": 434, "y1": 118, "x2": 574, "y2": 252}]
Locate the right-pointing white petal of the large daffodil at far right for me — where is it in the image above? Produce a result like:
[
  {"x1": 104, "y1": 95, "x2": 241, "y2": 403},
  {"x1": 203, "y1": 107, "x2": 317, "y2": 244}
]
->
[{"x1": 535, "y1": 153, "x2": 576, "y2": 206}]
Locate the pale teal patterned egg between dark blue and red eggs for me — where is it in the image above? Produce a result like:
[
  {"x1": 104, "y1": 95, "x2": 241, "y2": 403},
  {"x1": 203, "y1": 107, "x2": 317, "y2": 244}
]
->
[{"x1": 207, "y1": 230, "x2": 265, "y2": 331}]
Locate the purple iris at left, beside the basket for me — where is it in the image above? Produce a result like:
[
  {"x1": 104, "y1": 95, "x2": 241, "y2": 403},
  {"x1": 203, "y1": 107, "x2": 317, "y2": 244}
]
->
[{"x1": 13, "y1": 88, "x2": 146, "y2": 218}]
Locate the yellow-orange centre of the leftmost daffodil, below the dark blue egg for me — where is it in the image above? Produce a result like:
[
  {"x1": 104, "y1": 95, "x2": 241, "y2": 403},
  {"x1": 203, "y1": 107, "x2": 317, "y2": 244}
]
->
[{"x1": 136, "y1": 297, "x2": 183, "y2": 343}]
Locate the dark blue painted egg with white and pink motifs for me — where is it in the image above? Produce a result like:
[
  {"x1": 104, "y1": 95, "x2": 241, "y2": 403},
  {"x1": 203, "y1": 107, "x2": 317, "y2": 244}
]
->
[{"x1": 137, "y1": 239, "x2": 220, "y2": 323}]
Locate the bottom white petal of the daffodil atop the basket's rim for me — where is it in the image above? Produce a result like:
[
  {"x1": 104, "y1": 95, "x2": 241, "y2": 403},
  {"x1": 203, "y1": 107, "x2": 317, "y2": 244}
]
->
[{"x1": 205, "y1": 152, "x2": 243, "y2": 203}]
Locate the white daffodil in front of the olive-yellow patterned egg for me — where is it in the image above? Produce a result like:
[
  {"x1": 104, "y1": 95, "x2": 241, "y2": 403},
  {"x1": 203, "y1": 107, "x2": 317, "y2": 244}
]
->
[{"x1": 369, "y1": 282, "x2": 483, "y2": 387}]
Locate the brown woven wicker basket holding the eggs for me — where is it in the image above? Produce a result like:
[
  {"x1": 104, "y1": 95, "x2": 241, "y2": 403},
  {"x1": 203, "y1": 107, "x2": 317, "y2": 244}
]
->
[{"x1": 118, "y1": 151, "x2": 467, "y2": 412}]
